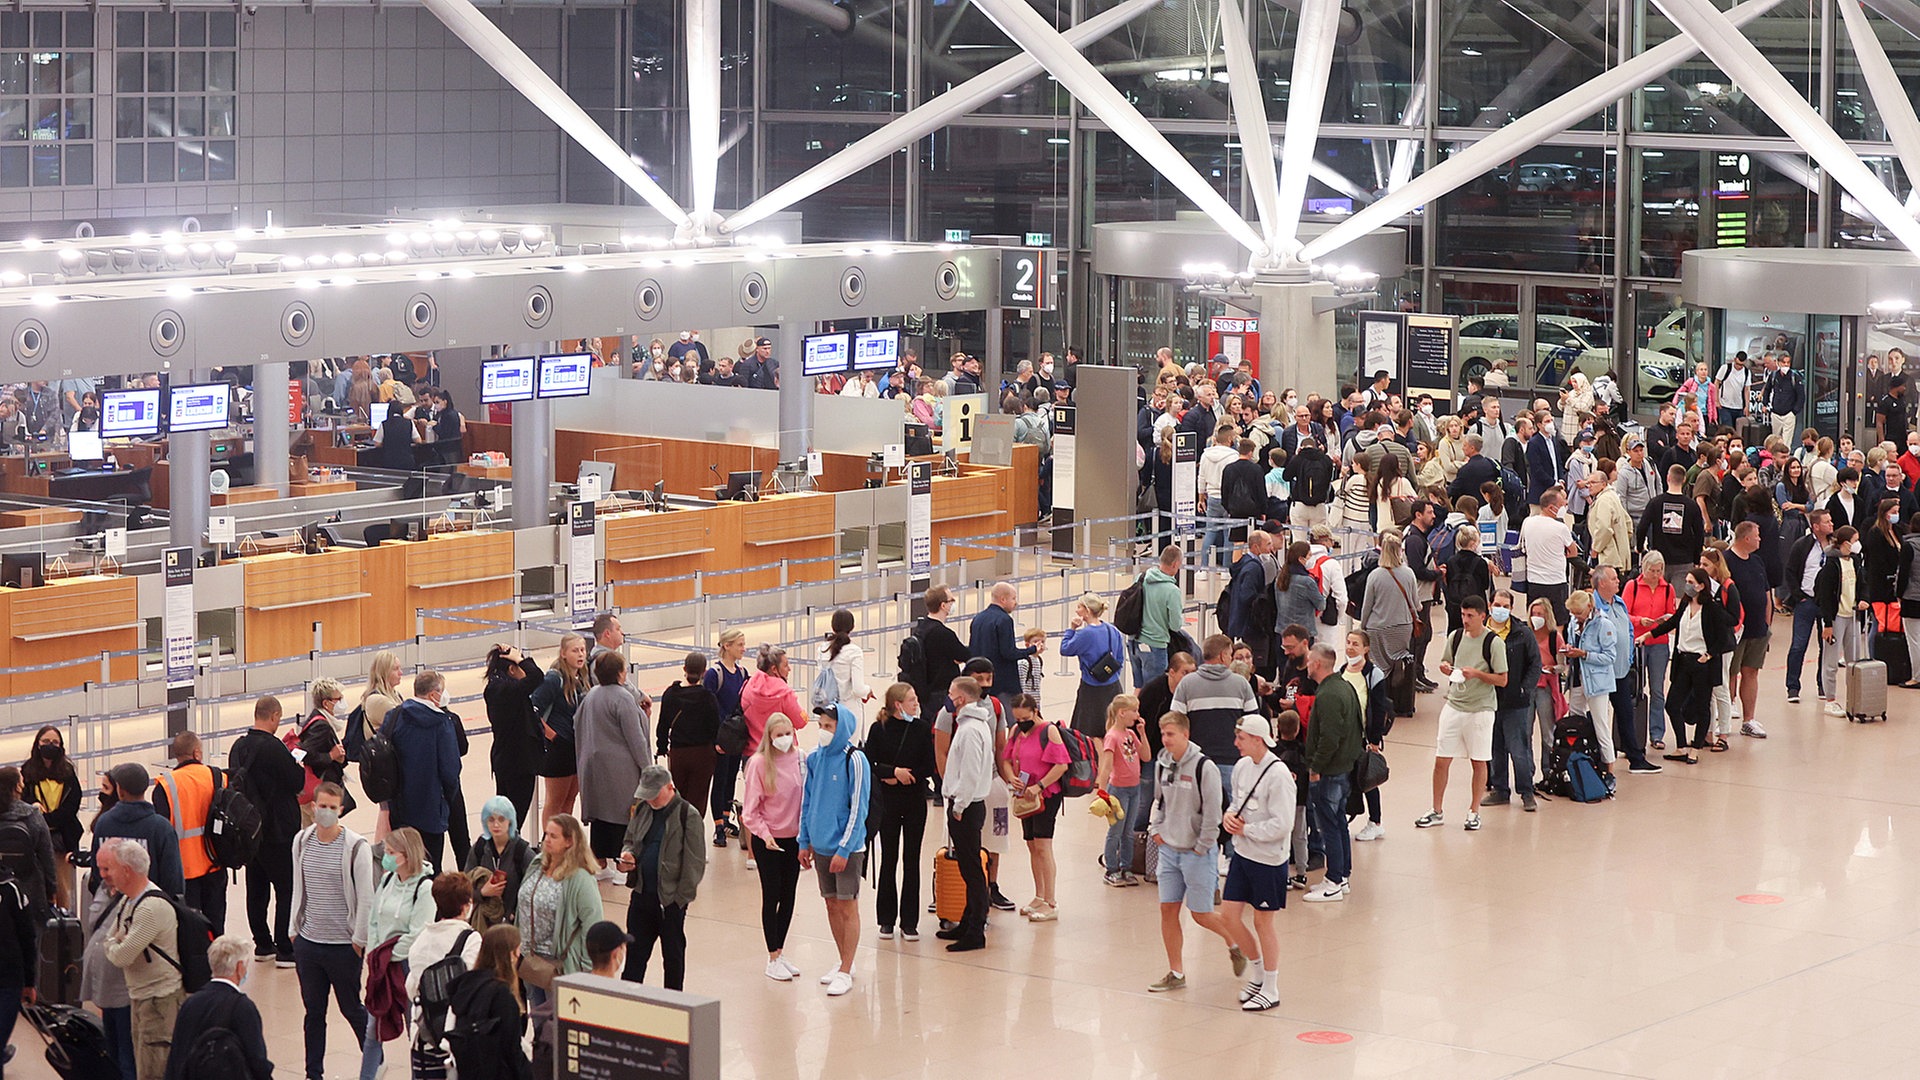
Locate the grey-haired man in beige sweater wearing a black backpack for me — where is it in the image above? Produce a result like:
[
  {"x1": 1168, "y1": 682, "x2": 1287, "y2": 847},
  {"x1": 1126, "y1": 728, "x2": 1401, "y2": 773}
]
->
[{"x1": 96, "y1": 838, "x2": 186, "y2": 1080}]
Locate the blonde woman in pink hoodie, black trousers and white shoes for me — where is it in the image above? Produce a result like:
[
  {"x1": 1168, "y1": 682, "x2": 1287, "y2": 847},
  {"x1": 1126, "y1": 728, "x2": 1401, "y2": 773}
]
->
[{"x1": 739, "y1": 713, "x2": 798, "y2": 982}]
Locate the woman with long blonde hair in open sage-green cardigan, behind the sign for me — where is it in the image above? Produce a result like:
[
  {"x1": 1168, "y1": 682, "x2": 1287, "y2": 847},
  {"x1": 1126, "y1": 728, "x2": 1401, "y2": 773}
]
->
[{"x1": 515, "y1": 813, "x2": 607, "y2": 1005}]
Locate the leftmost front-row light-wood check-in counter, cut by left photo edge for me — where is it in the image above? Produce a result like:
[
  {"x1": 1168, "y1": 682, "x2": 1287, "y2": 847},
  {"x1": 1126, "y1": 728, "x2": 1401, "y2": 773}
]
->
[{"x1": 0, "y1": 575, "x2": 140, "y2": 694}]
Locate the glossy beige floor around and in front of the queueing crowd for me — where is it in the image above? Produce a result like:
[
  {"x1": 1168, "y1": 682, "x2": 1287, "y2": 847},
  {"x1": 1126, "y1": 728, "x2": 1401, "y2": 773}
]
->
[{"x1": 13, "y1": 626, "x2": 1920, "y2": 1080}]
